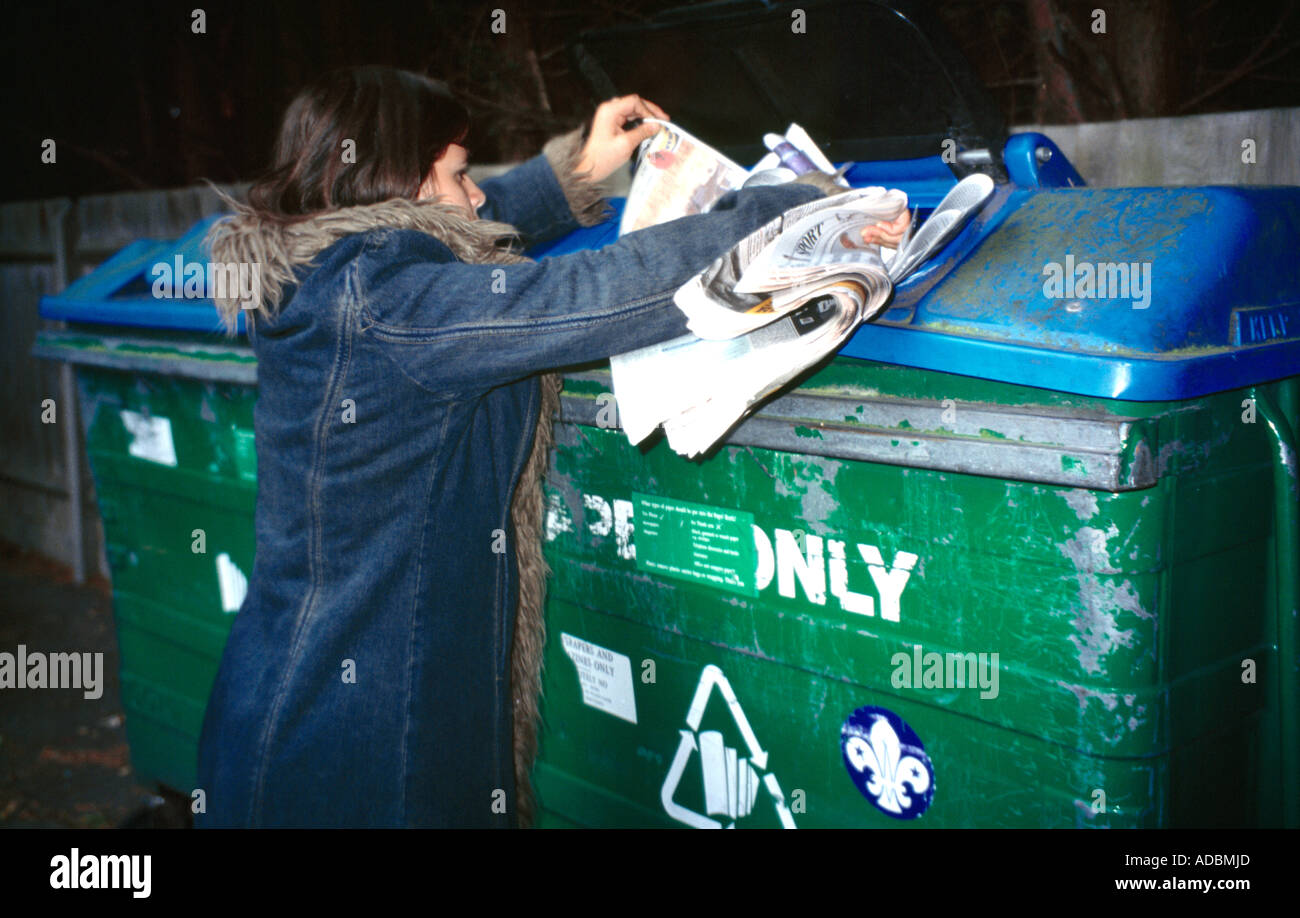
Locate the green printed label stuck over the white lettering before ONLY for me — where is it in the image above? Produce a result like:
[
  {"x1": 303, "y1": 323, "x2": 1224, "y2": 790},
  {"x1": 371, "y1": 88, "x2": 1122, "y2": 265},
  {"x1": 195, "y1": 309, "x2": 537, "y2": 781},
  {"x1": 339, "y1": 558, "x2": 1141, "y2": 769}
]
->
[{"x1": 632, "y1": 493, "x2": 758, "y2": 596}]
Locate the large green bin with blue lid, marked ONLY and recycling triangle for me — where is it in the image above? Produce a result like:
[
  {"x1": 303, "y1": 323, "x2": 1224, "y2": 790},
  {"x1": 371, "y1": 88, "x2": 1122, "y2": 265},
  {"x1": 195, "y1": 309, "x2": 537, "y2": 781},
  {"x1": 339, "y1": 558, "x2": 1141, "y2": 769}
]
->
[{"x1": 536, "y1": 186, "x2": 1300, "y2": 828}]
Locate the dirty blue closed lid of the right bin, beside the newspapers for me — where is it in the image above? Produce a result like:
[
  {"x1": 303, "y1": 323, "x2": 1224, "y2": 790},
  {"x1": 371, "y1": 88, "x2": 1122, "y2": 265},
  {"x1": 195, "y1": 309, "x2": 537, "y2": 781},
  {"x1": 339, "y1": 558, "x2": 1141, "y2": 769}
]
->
[{"x1": 840, "y1": 186, "x2": 1300, "y2": 402}]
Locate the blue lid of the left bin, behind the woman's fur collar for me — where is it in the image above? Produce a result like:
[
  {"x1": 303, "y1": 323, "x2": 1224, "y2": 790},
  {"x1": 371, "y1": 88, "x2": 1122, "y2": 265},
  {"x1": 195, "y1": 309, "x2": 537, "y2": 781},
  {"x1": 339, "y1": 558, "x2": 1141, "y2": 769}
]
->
[{"x1": 40, "y1": 215, "x2": 244, "y2": 334}]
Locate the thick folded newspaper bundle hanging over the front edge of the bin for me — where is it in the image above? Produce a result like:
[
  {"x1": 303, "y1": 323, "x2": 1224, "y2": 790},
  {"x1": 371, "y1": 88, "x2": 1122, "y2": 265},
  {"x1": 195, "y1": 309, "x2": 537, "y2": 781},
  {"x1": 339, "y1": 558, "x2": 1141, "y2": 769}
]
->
[{"x1": 610, "y1": 144, "x2": 993, "y2": 456}]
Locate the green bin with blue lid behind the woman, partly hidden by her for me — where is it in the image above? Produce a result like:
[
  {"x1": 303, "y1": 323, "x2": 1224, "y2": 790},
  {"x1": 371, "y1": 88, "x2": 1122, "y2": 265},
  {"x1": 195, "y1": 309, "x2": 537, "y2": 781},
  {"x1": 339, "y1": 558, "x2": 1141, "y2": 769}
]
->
[{"x1": 33, "y1": 220, "x2": 257, "y2": 794}]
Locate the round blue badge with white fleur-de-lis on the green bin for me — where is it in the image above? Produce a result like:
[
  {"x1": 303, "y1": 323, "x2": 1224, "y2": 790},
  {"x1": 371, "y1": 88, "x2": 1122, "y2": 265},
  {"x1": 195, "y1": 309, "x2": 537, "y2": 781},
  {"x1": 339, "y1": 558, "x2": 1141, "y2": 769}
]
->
[{"x1": 840, "y1": 707, "x2": 935, "y2": 819}]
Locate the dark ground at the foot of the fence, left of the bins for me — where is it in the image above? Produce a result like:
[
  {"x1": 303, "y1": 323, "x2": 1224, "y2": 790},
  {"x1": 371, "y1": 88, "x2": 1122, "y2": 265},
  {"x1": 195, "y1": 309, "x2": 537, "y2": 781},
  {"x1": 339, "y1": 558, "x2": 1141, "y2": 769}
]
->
[{"x1": 0, "y1": 542, "x2": 185, "y2": 828}]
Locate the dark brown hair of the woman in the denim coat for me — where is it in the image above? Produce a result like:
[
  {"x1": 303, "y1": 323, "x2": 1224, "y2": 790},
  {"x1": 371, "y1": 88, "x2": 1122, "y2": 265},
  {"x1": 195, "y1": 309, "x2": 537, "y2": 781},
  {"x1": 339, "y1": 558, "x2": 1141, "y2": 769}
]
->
[{"x1": 248, "y1": 66, "x2": 469, "y2": 222}]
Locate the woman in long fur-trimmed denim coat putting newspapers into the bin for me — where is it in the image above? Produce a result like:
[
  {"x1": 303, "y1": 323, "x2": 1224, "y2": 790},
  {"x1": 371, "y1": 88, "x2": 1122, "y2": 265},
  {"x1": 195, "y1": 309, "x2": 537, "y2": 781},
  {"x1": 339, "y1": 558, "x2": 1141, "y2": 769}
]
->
[{"x1": 196, "y1": 68, "x2": 904, "y2": 827}]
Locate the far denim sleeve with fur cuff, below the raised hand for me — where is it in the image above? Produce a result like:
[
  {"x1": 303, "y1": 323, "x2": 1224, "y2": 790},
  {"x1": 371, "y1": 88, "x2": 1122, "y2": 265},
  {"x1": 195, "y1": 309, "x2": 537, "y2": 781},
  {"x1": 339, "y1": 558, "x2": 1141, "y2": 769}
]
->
[{"x1": 478, "y1": 130, "x2": 608, "y2": 247}]
